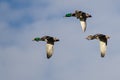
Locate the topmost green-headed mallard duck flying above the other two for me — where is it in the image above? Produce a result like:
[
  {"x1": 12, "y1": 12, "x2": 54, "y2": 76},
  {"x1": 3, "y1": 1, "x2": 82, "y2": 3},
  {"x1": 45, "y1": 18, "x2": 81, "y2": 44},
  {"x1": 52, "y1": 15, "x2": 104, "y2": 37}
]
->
[{"x1": 64, "y1": 10, "x2": 92, "y2": 32}]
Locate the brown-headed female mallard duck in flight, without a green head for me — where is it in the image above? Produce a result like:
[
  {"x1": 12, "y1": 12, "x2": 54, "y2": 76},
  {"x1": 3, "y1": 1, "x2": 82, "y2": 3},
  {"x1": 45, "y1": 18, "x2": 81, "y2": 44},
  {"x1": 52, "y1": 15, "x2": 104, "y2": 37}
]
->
[{"x1": 86, "y1": 34, "x2": 110, "y2": 57}]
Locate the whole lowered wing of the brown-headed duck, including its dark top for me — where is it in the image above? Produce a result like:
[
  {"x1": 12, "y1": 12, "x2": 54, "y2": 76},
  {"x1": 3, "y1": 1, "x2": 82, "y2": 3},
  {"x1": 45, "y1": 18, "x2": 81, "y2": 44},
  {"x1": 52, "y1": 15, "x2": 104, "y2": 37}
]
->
[{"x1": 100, "y1": 38, "x2": 107, "y2": 57}]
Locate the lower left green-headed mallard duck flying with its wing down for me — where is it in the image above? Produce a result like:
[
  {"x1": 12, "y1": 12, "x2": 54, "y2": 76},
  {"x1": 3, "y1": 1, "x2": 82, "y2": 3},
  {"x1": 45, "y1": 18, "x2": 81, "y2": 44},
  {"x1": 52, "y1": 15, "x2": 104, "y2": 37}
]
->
[{"x1": 33, "y1": 36, "x2": 59, "y2": 59}]
